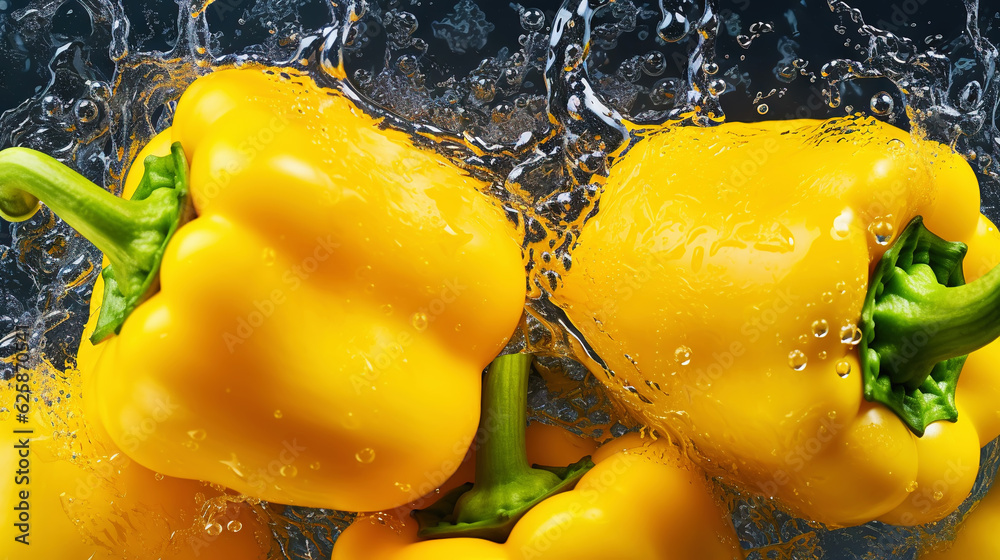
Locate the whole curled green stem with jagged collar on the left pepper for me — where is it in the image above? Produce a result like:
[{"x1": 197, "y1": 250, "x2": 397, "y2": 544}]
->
[{"x1": 0, "y1": 144, "x2": 191, "y2": 342}]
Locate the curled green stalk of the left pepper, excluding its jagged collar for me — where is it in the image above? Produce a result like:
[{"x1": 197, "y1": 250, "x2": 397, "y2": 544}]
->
[{"x1": 0, "y1": 148, "x2": 170, "y2": 293}]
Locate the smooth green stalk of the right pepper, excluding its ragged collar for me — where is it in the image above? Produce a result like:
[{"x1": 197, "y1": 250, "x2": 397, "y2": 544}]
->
[{"x1": 900, "y1": 267, "x2": 1000, "y2": 374}]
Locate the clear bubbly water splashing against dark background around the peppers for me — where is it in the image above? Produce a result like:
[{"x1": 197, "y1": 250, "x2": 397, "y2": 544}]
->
[{"x1": 0, "y1": 0, "x2": 1000, "y2": 558}]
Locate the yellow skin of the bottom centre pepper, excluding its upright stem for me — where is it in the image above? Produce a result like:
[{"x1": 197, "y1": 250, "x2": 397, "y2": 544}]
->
[{"x1": 332, "y1": 424, "x2": 742, "y2": 560}]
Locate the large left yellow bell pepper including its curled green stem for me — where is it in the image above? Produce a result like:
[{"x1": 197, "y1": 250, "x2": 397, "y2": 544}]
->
[{"x1": 0, "y1": 66, "x2": 525, "y2": 511}]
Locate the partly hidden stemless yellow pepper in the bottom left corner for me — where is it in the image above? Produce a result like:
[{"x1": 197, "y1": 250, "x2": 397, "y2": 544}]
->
[{"x1": 0, "y1": 356, "x2": 272, "y2": 560}]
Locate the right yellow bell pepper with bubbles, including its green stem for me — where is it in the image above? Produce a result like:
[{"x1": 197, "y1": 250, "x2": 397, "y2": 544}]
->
[{"x1": 553, "y1": 118, "x2": 1000, "y2": 525}]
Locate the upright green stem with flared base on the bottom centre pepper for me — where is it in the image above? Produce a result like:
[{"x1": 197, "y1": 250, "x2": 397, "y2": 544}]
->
[{"x1": 413, "y1": 354, "x2": 593, "y2": 542}]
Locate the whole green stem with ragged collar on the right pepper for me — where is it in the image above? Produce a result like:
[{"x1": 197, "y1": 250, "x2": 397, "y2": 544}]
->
[{"x1": 859, "y1": 217, "x2": 1000, "y2": 435}]
